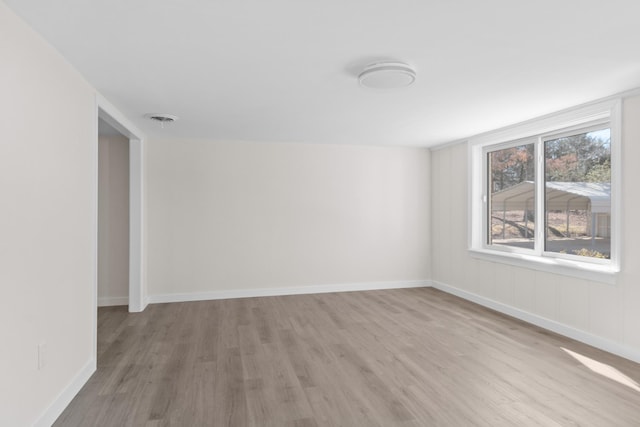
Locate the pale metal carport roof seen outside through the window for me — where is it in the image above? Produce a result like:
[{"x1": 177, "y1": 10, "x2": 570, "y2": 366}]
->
[{"x1": 491, "y1": 181, "x2": 611, "y2": 214}]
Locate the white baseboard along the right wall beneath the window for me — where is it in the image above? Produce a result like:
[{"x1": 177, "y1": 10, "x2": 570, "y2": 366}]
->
[{"x1": 431, "y1": 280, "x2": 640, "y2": 363}]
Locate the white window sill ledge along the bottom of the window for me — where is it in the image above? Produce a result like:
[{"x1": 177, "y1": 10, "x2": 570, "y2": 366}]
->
[{"x1": 469, "y1": 248, "x2": 619, "y2": 285}]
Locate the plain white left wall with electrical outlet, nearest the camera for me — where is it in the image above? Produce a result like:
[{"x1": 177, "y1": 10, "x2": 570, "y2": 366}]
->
[{"x1": 0, "y1": 2, "x2": 96, "y2": 426}]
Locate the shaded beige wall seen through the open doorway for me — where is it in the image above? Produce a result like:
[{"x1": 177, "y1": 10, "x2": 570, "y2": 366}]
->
[{"x1": 98, "y1": 135, "x2": 129, "y2": 306}]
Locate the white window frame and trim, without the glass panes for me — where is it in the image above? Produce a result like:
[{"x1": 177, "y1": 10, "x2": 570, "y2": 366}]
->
[{"x1": 468, "y1": 98, "x2": 622, "y2": 284}]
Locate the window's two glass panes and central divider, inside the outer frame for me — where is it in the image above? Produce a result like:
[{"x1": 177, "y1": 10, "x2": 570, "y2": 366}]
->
[{"x1": 485, "y1": 124, "x2": 611, "y2": 259}]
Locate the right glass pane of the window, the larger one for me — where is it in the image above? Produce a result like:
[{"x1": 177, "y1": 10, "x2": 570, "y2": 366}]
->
[{"x1": 544, "y1": 128, "x2": 611, "y2": 259}]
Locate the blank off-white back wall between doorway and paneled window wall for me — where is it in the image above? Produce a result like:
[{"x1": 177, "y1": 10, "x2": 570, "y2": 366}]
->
[{"x1": 146, "y1": 140, "x2": 430, "y2": 302}]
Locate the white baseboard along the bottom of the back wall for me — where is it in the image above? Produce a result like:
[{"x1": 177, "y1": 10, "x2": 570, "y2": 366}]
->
[{"x1": 148, "y1": 280, "x2": 431, "y2": 304}]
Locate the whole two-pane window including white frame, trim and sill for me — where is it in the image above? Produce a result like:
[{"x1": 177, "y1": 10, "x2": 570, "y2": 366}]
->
[{"x1": 469, "y1": 101, "x2": 620, "y2": 282}]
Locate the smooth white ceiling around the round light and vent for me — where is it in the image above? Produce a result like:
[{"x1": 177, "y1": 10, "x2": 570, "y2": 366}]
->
[{"x1": 5, "y1": 0, "x2": 640, "y2": 146}]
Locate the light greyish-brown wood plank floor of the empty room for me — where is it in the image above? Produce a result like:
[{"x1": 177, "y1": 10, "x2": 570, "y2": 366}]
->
[{"x1": 55, "y1": 288, "x2": 640, "y2": 427}]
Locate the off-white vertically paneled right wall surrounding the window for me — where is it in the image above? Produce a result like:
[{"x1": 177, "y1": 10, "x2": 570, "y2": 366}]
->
[{"x1": 431, "y1": 93, "x2": 640, "y2": 361}]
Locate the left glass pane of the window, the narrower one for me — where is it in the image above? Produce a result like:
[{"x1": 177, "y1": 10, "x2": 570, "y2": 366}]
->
[{"x1": 487, "y1": 144, "x2": 535, "y2": 249}]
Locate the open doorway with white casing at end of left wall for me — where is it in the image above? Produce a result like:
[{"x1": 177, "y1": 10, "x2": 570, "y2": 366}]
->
[{"x1": 94, "y1": 97, "x2": 147, "y2": 314}]
